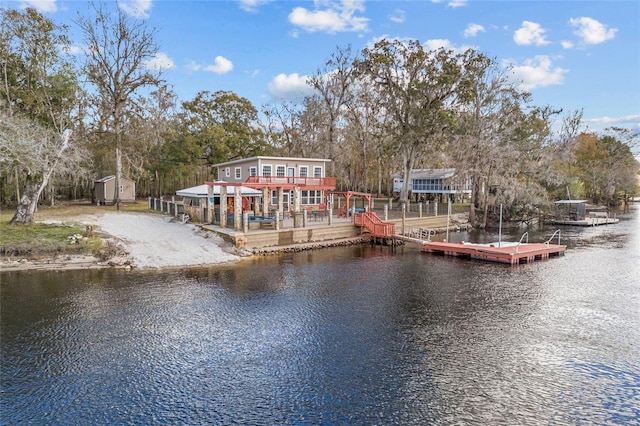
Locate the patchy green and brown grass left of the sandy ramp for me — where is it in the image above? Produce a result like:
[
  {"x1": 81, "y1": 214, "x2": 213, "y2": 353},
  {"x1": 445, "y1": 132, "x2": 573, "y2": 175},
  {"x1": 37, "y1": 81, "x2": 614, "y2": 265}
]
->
[{"x1": 0, "y1": 202, "x2": 148, "y2": 259}]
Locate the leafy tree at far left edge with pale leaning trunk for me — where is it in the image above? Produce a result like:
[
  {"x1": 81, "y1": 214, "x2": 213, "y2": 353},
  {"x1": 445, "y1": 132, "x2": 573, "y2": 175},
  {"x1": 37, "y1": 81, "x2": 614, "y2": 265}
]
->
[{"x1": 0, "y1": 8, "x2": 83, "y2": 213}]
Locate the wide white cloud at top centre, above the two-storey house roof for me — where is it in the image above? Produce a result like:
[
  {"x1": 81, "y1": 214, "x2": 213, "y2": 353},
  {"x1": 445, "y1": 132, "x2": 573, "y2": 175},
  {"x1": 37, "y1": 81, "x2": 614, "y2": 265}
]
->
[{"x1": 289, "y1": 0, "x2": 369, "y2": 34}]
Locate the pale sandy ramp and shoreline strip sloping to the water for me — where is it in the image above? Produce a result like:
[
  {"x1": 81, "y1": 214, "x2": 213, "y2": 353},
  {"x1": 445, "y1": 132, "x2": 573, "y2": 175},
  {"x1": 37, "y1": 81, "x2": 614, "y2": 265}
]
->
[{"x1": 0, "y1": 212, "x2": 241, "y2": 271}]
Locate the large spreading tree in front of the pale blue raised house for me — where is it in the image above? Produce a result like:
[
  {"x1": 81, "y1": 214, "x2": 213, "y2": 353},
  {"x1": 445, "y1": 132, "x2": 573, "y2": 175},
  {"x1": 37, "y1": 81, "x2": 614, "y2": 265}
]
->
[{"x1": 356, "y1": 40, "x2": 477, "y2": 202}]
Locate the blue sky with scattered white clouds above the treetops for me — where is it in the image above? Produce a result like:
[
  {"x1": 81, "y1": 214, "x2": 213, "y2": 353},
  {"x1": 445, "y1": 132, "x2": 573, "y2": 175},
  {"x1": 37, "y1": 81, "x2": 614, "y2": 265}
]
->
[{"x1": 5, "y1": 0, "x2": 640, "y2": 131}]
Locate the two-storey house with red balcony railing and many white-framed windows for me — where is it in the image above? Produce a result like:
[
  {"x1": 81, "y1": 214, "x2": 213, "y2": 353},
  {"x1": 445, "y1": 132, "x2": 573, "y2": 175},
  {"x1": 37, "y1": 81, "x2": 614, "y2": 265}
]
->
[{"x1": 213, "y1": 156, "x2": 336, "y2": 212}]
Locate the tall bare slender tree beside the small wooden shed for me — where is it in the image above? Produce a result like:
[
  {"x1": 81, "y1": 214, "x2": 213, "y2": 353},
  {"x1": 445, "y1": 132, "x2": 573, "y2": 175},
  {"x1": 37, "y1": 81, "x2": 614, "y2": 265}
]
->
[{"x1": 77, "y1": 3, "x2": 160, "y2": 209}]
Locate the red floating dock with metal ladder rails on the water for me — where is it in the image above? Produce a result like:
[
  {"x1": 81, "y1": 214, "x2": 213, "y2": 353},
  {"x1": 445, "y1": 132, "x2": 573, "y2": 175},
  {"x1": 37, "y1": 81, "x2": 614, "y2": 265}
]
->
[{"x1": 420, "y1": 241, "x2": 567, "y2": 265}]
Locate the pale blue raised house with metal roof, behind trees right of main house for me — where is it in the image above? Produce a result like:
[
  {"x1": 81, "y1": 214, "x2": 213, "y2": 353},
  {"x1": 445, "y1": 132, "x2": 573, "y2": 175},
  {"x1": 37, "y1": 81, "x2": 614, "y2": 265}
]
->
[{"x1": 392, "y1": 169, "x2": 471, "y2": 201}]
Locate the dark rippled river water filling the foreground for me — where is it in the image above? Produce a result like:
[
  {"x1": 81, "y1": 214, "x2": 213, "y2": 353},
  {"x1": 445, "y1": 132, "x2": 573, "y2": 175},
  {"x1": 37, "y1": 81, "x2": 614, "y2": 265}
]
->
[{"x1": 0, "y1": 209, "x2": 640, "y2": 425}]
